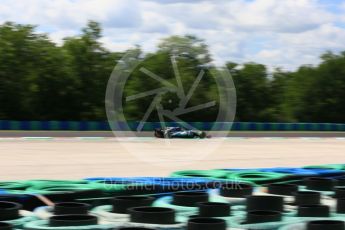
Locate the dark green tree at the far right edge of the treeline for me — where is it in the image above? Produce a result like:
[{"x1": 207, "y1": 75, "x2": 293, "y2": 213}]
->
[{"x1": 298, "y1": 52, "x2": 345, "y2": 122}]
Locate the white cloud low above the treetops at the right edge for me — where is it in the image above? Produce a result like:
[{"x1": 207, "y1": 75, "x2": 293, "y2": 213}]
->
[{"x1": 247, "y1": 24, "x2": 345, "y2": 69}]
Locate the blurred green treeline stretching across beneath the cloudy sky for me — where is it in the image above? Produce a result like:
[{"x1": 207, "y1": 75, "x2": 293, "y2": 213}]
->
[{"x1": 0, "y1": 21, "x2": 345, "y2": 122}]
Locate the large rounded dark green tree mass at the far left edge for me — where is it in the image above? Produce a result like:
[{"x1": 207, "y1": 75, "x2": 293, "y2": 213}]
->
[{"x1": 0, "y1": 23, "x2": 75, "y2": 120}]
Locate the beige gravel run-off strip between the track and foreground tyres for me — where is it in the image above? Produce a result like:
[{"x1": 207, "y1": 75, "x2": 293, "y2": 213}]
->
[{"x1": 0, "y1": 135, "x2": 345, "y2": 180}]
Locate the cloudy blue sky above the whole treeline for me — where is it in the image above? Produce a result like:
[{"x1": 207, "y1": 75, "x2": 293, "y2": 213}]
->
[{"x1": 0, "y1": 0, "x2": 345, "y2": 70}]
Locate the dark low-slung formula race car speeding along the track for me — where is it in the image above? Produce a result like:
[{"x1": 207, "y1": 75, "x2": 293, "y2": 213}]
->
[{"x1": 154, "y1": 127, "x2": 210, "y2": 139}]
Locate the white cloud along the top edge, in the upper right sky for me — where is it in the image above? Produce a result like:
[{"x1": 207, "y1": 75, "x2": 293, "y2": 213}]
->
[{"x1": 223, "y1": 0, "x2": 334, "y2": 33}]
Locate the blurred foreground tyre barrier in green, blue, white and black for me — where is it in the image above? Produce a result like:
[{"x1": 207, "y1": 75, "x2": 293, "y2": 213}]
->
[{"x1": 0, "y1": 164, "x2": 345, "y2": 230}]
